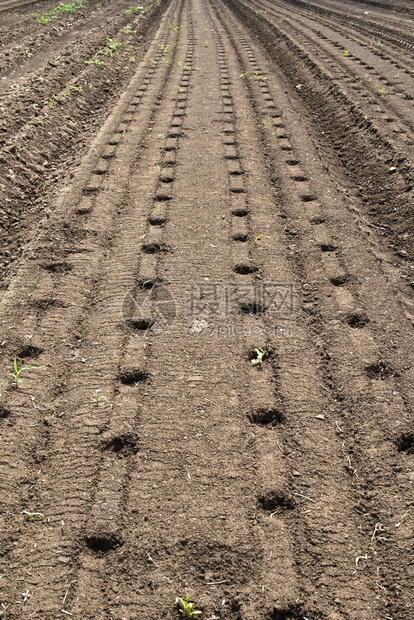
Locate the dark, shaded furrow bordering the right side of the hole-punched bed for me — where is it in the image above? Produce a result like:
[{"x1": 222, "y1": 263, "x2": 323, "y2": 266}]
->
[{"x1": 225, "y1": 2, "x2": 413, "y2": 257}]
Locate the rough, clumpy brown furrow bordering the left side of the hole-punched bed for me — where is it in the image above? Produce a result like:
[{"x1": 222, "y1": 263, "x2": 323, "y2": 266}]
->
[{"x1": 0, "y1": 0, "x2": 171, "y2": 287}]
